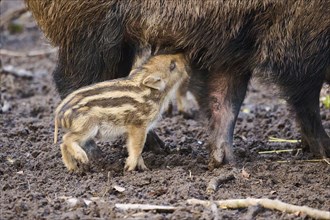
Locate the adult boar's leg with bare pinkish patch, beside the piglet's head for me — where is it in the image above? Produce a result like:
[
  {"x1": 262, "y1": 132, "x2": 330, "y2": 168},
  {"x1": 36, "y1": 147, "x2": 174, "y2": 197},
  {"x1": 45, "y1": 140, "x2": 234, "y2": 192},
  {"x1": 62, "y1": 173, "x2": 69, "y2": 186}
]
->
[{"x1": 206, "y1": 69, "x2": 251, "y2": 169}]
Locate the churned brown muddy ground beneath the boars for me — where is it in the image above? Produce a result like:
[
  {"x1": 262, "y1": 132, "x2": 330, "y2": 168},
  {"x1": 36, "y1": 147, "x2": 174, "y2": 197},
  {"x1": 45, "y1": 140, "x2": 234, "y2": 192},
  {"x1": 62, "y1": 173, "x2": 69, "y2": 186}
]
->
[{"x1": 0, "y1": 0, "x2": 330, "y2": 219}]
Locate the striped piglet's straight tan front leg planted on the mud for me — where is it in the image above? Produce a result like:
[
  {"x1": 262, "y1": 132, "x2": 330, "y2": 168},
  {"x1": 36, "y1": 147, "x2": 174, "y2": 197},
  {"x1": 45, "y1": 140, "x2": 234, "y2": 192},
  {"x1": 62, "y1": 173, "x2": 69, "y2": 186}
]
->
[{"x1": 125, "y1": 126, "x2": 148, "y2": 171}]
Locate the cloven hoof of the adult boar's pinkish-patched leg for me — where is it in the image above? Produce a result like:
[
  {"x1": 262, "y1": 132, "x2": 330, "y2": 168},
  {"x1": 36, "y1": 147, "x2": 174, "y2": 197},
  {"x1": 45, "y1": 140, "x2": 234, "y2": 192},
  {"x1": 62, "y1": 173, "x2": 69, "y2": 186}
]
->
[{"x1": 208, "y1": 142, "x2": 235, "y2": 170}]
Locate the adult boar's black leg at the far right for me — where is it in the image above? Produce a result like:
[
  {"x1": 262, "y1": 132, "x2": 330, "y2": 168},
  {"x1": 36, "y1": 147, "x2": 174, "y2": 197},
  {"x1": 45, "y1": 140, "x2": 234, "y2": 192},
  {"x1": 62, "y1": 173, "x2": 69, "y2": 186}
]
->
[{"x1": 282, "y1": 74, "x2": 330, "y2": 157}]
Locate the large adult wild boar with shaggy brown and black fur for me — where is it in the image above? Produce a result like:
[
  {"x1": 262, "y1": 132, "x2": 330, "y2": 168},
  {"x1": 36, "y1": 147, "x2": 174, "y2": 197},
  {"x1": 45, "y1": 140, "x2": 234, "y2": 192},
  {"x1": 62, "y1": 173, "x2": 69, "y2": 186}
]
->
[{"x1": 25, "y1": 0, "x2": 330, "y2": 168}]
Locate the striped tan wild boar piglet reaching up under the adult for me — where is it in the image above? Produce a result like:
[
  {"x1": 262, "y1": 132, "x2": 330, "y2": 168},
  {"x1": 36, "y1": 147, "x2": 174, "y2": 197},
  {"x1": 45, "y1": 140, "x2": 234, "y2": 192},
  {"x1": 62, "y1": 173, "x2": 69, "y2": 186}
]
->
[{"x1": 54, "y1": 54, "x2": 188, "y2": 171}]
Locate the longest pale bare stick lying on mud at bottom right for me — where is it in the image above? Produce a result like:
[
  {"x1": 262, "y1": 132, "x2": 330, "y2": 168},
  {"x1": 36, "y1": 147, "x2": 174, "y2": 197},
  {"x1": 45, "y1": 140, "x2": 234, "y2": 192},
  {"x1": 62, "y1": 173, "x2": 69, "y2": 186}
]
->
[{"x1": 187, "y1": 198, "x2": 330, "y2": 219}]
